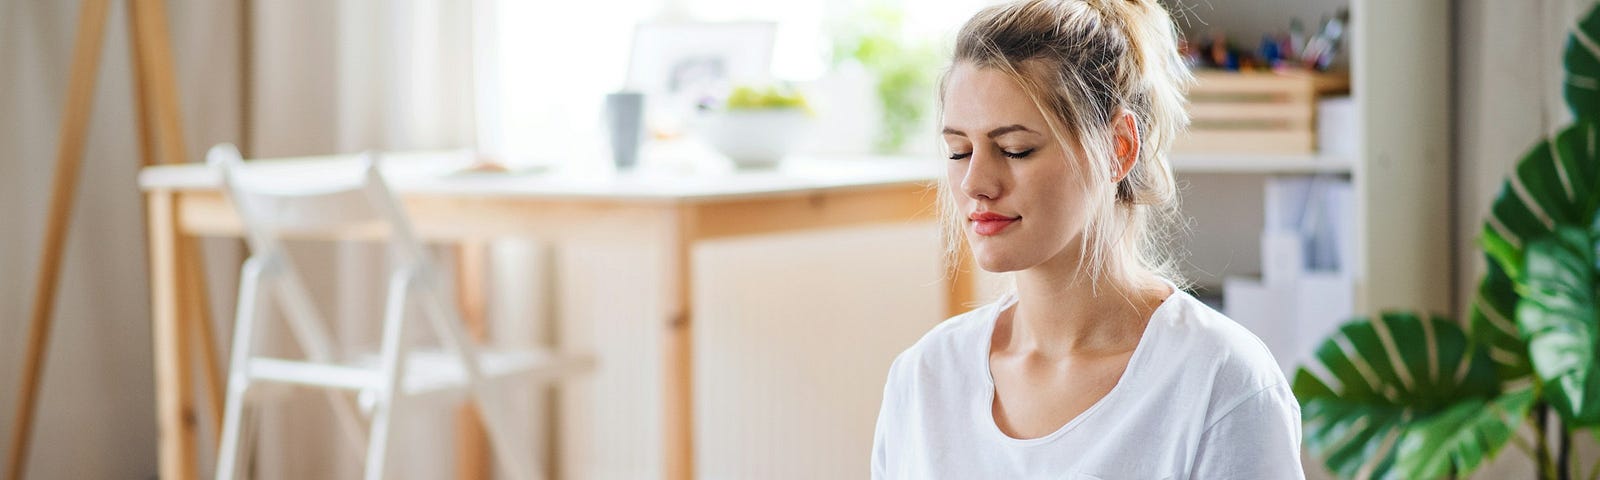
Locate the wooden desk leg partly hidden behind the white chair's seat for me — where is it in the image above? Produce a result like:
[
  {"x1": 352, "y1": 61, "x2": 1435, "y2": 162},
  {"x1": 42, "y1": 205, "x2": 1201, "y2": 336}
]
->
[{"x1": 456, "y1": 240, "x2": 489, "y2": 480}]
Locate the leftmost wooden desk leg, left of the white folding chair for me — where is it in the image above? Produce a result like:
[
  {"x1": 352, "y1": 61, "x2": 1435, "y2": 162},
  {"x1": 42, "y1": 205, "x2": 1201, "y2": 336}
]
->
[{"x1": 146, "y1": 190, "x2": 197, "y2": 480}]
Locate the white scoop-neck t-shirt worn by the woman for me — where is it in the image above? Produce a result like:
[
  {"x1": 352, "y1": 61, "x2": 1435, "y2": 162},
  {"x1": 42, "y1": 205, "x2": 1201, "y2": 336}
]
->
[{"x1": 872, "y1": 288, "x2": 1304, "y2": 480}]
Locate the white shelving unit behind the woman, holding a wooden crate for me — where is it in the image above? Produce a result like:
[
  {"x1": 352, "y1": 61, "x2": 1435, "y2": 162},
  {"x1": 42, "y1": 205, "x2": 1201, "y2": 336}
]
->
[{"x1": 1171, "y1": 0, "x2": 1453, "y2": 318}]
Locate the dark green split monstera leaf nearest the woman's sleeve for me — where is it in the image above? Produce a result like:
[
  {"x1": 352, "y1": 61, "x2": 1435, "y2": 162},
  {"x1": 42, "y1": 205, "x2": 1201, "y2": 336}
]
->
[{"x1": 1294, "y1": 312, "x2": 1499, "y2": 478}]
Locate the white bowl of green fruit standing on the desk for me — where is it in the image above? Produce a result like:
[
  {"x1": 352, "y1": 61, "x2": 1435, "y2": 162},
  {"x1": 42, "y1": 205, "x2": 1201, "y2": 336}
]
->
[{"x1": 699, "y1": 109, "x2": 810, "y2": 168}]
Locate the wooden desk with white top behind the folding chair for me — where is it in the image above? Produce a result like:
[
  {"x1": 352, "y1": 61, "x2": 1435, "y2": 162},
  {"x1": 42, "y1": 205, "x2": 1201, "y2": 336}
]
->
[{"x1": 139, "y1": 152, "x2": 973, "y2": 480}]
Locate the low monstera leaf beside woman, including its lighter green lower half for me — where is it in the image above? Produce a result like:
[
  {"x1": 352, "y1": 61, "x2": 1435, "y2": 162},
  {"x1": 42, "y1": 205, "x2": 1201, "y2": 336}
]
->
[{"x1": 1294, "y1": 312, "x2": 1510, "y2": 478}]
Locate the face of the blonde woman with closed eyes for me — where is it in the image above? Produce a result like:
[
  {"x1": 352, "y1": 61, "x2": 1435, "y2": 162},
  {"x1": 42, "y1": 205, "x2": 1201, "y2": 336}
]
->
[{"x1": 944, "y1": 62, "x2": 1109, "y2": 272}]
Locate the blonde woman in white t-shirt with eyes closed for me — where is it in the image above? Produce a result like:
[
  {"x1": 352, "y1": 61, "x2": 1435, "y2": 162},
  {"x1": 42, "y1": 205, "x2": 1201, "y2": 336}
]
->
[{"x1": 872, "y1": 0, "x2": 1304, "y2": 480}]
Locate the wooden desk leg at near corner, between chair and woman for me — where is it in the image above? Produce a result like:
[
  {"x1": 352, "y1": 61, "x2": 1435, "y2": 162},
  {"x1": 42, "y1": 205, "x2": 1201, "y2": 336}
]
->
[{"x1": 662, "y1": 205, "x2": 696, "y2": 480}]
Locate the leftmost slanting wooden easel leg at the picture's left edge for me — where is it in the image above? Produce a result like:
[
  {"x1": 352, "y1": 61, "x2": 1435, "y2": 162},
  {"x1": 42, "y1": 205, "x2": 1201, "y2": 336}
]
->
[{"x1": 6, "y1": 0, "x2": 109, "y2": 480}]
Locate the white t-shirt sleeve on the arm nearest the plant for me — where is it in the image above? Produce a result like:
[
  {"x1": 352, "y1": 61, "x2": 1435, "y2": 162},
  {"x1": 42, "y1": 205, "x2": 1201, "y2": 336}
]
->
[{"x1": 1189, "y1": 384, "x2": 1306, "y2": 480}]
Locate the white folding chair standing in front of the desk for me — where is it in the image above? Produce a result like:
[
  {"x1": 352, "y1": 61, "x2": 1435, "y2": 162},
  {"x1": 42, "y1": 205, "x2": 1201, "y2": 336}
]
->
[{"x1": 206, "y1": 144, "x2": 579, "y2": 480}]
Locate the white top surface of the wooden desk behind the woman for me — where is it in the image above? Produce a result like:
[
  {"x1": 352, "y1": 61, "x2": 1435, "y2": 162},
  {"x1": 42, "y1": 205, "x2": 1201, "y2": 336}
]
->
[{"x1": 139, "y1": 150, "x2": 944, "y2": 202}]
